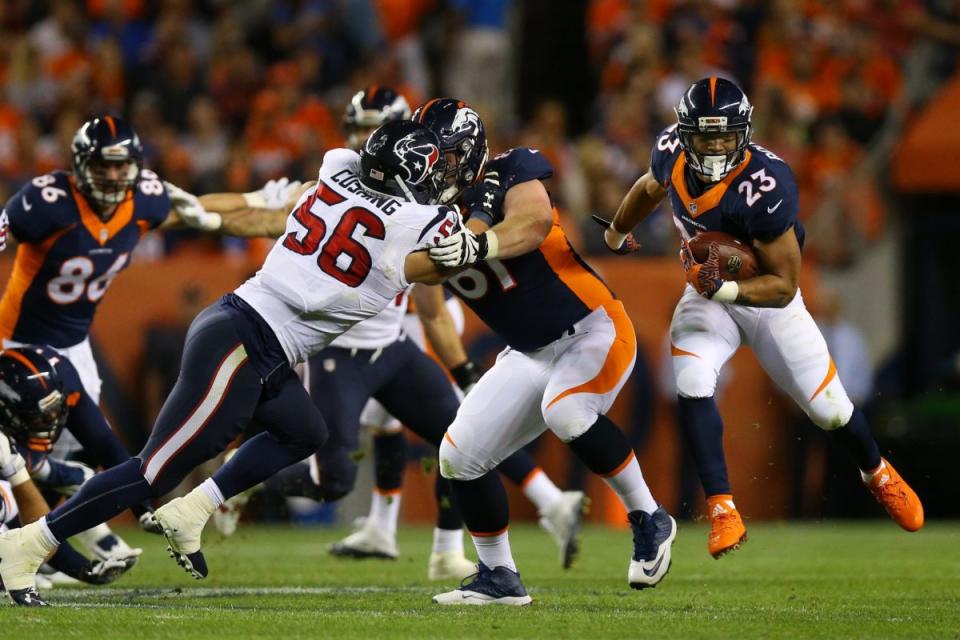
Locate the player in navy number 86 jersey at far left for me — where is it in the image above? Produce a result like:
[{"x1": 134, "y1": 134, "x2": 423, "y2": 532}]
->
[{"x1": 0, "y1": 115, "x2": 219, "y2": 551}]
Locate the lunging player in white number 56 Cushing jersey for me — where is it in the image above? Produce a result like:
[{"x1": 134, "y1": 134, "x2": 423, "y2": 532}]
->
[{"x1": 0, "y1": 121, "x2": 460, "y2": 604}]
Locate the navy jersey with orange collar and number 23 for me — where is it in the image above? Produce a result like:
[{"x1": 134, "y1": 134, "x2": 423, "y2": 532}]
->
[{"x1": 650, "y1": 125, "x2": 805, "y2": 249}]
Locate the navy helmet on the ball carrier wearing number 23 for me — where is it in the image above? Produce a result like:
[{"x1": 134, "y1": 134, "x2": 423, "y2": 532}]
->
[{"x1": 674, "y1": 76, "x2": 753, "y2": 182}]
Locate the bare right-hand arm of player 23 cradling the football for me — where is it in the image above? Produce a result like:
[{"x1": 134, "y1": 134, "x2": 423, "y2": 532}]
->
[{"x1": 736, "y1": 227, "x2": 801, "y2": 308}]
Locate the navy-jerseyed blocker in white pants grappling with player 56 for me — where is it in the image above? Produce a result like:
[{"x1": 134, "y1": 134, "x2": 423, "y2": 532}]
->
[{"x1": 413, "y1": 98, "x2": 676, "y2": 605}]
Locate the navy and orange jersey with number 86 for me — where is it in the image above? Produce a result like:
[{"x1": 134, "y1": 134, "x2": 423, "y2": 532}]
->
[{"x1": 0, "y1": 170, "x2": 170, "y2": 348}]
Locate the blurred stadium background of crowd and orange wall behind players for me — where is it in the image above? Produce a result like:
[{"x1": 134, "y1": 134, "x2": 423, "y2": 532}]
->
[{"x1": 0, "y1": 0, "x2": 960, "y2": 523}]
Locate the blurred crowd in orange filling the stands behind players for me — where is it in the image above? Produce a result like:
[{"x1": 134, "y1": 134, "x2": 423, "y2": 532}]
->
[{"x1": 0, "y1": 0, "x2": 960, "y2": 266}]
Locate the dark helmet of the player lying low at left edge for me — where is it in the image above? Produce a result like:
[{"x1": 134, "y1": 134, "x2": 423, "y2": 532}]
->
[{"x1": 0, "y1": 347, "x2": 69, "y2": 451}]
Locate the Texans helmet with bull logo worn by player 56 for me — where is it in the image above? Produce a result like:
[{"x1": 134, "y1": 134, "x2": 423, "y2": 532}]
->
[{"x1": 360, "y1": 120, "x2": 447, "y2": 204}]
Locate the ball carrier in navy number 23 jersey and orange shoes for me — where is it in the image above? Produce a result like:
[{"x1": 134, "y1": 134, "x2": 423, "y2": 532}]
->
[{"x1": 604, "y1": 77, "x2": 923, "y2": 557}]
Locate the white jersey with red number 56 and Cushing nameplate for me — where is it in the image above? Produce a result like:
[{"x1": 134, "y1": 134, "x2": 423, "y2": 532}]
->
[{"x1": 235, "y1": 149, "x2": 459, "y2": 364}]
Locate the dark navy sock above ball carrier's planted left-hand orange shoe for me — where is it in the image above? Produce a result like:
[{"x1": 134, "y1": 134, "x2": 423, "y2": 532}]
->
[{"x1": 677, "y1": 397, "x2": 730, "y2": 496}]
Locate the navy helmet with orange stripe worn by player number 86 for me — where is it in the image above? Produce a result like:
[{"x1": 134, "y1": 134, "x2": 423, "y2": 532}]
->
[{"x1": 70, "y1": 116, "x2": 143, "y2": 209}]
